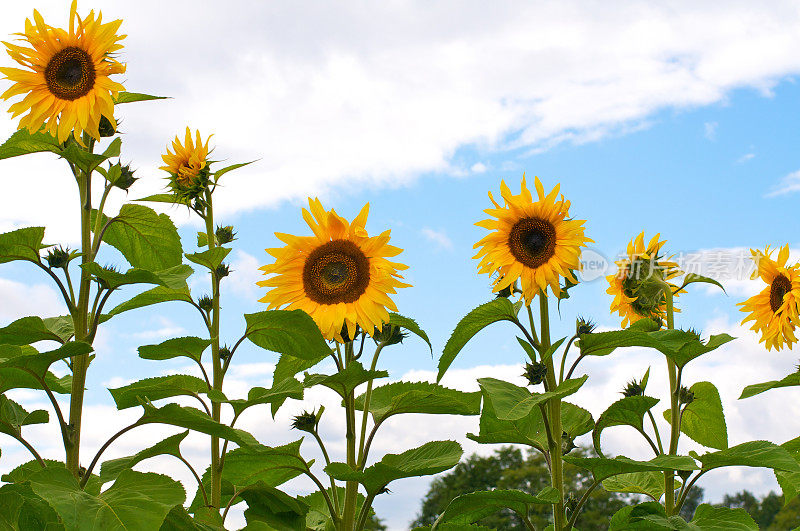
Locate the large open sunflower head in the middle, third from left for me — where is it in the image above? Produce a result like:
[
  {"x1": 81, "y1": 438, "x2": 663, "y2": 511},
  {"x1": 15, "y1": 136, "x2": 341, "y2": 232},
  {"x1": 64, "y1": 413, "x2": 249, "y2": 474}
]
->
[{"x1": 258, "y1": 198, "x2": 409, "y2": 342}]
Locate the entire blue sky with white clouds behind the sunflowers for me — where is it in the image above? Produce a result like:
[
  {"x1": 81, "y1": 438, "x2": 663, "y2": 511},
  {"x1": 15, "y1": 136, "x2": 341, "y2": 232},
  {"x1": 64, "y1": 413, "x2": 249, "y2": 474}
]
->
[{"x1": 0, "y1": 2, "x2": 800, "y2": 530}]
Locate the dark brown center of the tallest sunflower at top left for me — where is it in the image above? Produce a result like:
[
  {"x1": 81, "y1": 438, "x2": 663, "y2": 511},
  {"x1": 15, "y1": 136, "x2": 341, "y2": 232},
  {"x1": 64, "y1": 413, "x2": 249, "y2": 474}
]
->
[{"x1": 44, "y1": 46, "x2": 96, "y2": 101}]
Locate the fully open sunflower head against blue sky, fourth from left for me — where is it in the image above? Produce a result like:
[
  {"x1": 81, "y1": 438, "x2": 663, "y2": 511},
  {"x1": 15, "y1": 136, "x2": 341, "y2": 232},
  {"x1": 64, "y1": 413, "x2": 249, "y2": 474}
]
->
[{"x1": 473, "y1": 174, "x2": 593, "y2": 304}]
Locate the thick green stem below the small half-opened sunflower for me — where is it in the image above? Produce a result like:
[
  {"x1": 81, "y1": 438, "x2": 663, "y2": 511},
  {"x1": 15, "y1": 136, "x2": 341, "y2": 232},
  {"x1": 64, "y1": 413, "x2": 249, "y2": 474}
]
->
[{"x1": 205, "y1": 191, "x2": 223, "y2": 509}]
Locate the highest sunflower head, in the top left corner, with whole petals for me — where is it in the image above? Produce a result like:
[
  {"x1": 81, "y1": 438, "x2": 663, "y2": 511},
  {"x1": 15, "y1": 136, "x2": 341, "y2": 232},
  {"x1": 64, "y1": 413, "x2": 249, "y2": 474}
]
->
[{"x1": 0, "y1": 1, "x2": 125, "y2": 143}]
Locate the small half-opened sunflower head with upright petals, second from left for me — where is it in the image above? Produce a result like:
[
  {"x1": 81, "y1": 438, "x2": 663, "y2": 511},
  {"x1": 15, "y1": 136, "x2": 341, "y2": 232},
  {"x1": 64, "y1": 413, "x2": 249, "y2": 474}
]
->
[{"x1": 160, "y1": 127, "x2": 211, "y2": 201}]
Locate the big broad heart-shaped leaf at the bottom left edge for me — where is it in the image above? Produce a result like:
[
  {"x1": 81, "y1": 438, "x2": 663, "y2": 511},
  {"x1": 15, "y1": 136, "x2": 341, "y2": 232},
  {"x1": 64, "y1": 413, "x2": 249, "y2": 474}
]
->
[{"x1": 30, "y1": 467, "x2": 186, "y2": 531}]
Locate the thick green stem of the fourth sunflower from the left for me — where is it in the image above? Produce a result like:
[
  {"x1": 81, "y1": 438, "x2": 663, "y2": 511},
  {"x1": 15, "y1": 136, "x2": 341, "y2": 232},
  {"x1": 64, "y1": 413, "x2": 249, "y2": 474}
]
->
[{"x1": 539, "y1": 293, "x2": 565, "y2": 531}]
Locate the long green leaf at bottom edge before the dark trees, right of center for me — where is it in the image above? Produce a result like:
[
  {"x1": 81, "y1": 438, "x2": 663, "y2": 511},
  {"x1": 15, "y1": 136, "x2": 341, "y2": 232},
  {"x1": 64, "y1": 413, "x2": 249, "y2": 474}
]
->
[{"x1": 431, "y1": 487, "x2": 561, "y2": 529}]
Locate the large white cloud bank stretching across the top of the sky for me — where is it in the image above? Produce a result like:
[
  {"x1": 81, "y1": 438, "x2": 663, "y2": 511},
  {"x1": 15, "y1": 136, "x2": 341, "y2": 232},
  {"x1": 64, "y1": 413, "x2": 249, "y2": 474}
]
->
[{"x1": 0, "y1": 0, "x2": 800, "y2": 232}]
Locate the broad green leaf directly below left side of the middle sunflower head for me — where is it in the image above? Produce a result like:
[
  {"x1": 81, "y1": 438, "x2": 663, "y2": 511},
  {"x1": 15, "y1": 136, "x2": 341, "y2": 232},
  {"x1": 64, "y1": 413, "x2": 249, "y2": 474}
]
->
[{"x1": 244, "y1": 310, "x2": 330, "y2": 360}]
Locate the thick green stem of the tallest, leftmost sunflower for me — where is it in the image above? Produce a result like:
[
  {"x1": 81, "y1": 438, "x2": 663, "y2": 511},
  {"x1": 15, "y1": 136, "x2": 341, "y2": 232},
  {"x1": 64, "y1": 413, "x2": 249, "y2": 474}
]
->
[{"x1": 65, "y1": 171, "x2": 94, "y2": 478}]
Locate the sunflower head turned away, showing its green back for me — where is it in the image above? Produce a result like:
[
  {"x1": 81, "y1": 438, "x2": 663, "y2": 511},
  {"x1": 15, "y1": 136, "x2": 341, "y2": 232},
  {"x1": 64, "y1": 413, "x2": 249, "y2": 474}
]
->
[{"x1": 606, "y1": 232, "x2": 682, "y2": 328}]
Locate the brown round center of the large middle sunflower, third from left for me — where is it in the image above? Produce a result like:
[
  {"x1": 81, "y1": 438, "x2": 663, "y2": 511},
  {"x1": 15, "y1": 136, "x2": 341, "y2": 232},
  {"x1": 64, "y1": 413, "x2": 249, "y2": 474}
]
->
[{"x1": 303, "y1": 240, "x2": 369, "y2": 304}]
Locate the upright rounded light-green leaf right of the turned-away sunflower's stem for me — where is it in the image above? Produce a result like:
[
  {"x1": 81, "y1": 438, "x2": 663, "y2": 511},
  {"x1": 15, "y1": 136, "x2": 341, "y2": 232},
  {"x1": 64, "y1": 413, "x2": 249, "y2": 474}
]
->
[{"x1": 664, "y1": 382, "x2": 728, "y2": 450}]
